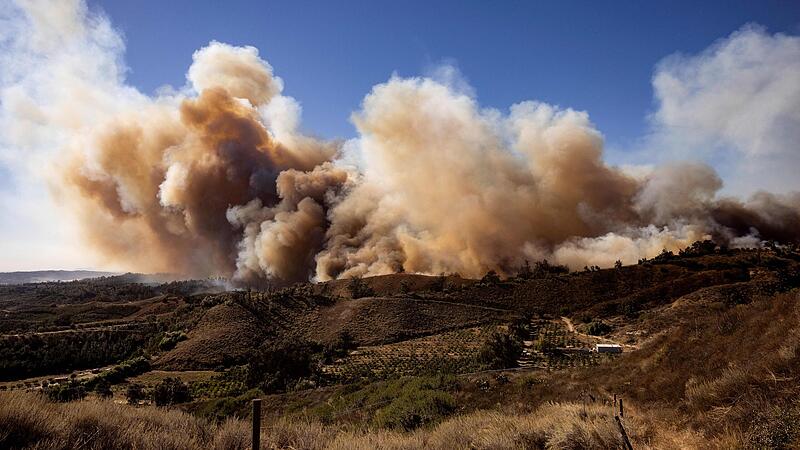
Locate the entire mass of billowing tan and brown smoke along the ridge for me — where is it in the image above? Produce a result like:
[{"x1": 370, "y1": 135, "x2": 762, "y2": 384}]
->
[{"x1": 5, "y1": 0, "x2": 800, "y2": 282}]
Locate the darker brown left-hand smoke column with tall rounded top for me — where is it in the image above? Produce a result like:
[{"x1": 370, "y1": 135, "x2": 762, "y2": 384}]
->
[{"x1": 57, "y1": 43, "x2": 347, "y2": 280}]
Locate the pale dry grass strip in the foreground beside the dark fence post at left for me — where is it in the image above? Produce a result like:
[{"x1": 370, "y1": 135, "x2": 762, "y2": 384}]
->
[{"x1": 0, "y1": 392, "x2": 621, "y2": 450}]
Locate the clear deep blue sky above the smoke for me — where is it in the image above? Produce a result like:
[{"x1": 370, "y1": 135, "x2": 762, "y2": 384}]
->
[{"x1": 90, "y1": 0, "x2": 800, "y2": 148}]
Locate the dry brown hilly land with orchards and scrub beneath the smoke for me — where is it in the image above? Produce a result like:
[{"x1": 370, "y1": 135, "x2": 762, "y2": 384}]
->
[{"x1": 0, "y1": 246, "x2": 800, "y2": 448}]
